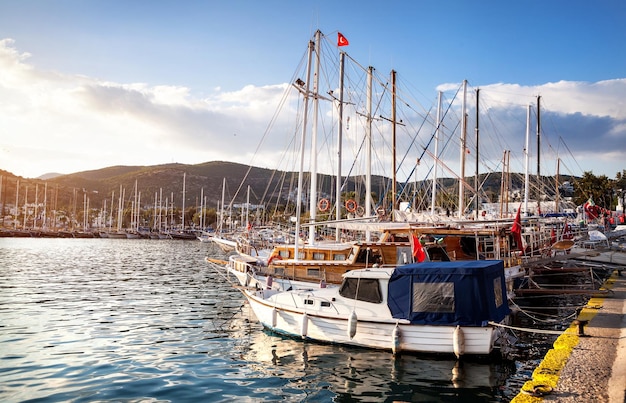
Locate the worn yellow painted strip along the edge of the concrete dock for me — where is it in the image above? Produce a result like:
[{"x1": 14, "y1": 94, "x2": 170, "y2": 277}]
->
[{"x1": 511, "y1": 270, "x2": 618, "y2": 403}]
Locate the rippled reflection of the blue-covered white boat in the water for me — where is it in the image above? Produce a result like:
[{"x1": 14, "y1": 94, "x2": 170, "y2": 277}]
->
[{"x1": 231, "y1": 306, "x2": 515, "y2": 402}]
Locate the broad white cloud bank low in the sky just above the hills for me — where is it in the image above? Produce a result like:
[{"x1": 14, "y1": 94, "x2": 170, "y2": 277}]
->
[{"x1": 0, "y1": 39, "x2": 626, "y2": 181}]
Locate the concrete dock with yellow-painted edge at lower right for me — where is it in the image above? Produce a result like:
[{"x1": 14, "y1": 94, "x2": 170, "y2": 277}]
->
[{"x1": 511, "y1": 269, "x2": 626, "y2": 403}]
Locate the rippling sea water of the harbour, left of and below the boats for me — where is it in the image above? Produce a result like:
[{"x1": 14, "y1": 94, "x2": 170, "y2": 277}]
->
[{"x1": 0, "y1": 238, "x2": 537, "y2": 402}]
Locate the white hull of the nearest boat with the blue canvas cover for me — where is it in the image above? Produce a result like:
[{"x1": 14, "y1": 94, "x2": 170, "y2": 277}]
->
[{"x1": 244, "y1": 290, "x2": 498, "y2": 355}]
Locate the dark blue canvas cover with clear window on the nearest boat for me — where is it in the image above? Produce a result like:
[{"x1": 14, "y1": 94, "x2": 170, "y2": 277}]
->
[{"x1": 387, "y1": 260, "x2": 510, "y2": 326}]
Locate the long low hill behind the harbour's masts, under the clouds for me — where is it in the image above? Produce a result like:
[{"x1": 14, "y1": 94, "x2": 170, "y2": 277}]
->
[{"x1": 0, "y1": 161, "x2": 569, "y2": 219}]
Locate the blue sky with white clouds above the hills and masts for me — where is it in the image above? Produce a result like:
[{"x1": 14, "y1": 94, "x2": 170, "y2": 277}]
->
[{"x1": 0, "y1": 0, "x2": 626, "y2": 178}]
